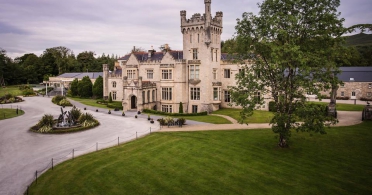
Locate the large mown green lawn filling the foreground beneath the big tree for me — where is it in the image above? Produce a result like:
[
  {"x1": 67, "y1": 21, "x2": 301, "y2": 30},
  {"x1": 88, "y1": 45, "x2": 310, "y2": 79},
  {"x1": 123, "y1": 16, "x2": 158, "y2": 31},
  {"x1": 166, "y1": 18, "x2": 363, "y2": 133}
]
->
[{"x1": 29, "y1": 122, "x2": 372, "y2": 195}]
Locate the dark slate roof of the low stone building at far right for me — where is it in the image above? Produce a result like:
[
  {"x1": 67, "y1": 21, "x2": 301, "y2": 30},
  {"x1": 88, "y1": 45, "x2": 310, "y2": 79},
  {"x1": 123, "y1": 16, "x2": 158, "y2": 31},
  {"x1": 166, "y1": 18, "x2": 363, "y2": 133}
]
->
[{"x1": 338, "y1": 66, "x2": 372, "y2": 82}]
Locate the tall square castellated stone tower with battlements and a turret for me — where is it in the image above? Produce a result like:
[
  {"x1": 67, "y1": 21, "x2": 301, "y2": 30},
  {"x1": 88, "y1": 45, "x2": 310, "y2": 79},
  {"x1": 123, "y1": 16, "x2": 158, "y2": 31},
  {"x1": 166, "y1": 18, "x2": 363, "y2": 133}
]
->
[{"x1": 181, "y1": 0, "x2": 223, "y2": 112}]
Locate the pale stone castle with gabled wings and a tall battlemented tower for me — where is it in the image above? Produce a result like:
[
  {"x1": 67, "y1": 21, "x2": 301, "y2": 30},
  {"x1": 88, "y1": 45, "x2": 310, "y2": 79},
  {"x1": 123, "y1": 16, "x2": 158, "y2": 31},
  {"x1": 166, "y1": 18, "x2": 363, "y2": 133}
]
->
[{"x1": 103, "y1": 0, "x2": 256, "y2": 113}]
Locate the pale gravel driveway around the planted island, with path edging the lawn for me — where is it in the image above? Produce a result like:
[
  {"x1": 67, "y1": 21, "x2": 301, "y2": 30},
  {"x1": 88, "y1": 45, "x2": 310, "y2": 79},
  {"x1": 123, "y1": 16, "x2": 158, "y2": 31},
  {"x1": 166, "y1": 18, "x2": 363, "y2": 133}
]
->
[{"x1": 0, "y1": 97, "x2": 361, "y2": 195}]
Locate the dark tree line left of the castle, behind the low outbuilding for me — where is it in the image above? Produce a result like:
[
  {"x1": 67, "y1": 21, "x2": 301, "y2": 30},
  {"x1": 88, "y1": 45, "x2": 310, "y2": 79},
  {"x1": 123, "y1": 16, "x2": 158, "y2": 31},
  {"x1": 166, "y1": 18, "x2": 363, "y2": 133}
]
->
[{"x1": 0, "y1": 46, "x2": 118, "y2": 85}]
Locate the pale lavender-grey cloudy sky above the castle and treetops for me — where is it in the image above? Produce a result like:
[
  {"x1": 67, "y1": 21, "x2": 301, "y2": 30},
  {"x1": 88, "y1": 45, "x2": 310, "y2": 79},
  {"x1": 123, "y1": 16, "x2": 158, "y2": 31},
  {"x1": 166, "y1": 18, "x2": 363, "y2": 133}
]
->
[{"x1": 0, "y1": 0, "x2": 372, "y2": 59}]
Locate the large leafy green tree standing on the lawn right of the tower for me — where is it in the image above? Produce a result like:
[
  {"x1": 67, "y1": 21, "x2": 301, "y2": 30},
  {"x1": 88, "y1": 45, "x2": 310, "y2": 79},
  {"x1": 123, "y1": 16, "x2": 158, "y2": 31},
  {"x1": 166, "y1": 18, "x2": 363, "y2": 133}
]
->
[{"x1": 231, "y1": 0, "x2": 345, "y2": 147}]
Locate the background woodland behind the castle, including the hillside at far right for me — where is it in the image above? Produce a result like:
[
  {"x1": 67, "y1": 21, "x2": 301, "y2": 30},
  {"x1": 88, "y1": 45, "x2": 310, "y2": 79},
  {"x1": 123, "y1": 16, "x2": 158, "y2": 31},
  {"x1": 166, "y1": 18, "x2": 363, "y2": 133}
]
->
[{"x1": 0, "y1": 33, "x2": 372, "y2": 85}]
